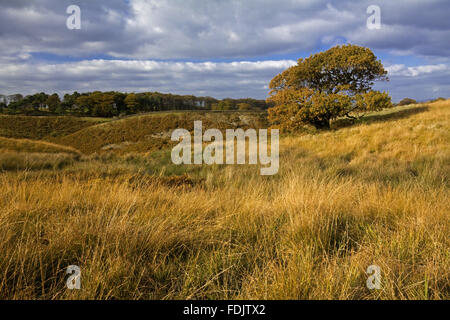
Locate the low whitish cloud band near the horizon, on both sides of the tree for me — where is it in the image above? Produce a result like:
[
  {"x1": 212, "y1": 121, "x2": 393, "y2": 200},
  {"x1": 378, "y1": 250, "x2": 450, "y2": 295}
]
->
[{"x1": 0, "y1": 59, "x2": 450, "y2": 101}]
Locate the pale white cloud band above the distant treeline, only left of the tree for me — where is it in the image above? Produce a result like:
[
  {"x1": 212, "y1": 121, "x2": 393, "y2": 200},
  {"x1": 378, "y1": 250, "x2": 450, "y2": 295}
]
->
[{"x1": 0, "y1": 60, "x2": 296, "y2": 98}]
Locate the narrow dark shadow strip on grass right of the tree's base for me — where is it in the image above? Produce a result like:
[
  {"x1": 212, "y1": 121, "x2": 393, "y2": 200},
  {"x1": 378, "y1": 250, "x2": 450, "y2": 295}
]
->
[{"x1": 331, "y1": 105, "x2": 429, "y2": 129}]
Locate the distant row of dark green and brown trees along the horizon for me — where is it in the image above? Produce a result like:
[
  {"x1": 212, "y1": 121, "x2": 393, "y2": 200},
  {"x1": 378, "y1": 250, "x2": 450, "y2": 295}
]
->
[{"x1": 0, "y1": 91, "x2": 271, "y2": 117}]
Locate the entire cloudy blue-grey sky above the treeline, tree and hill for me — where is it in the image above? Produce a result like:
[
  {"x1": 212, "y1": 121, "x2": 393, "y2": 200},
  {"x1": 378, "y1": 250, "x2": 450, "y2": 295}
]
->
[{"x1": 0, "y1": 0, "x2": 450, "y2": 101}]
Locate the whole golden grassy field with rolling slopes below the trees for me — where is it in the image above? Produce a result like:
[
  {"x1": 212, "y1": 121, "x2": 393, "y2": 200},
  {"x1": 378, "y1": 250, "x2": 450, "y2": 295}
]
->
[{"x1": 0, "y1": 100, "x2": 450, "y2": 299}]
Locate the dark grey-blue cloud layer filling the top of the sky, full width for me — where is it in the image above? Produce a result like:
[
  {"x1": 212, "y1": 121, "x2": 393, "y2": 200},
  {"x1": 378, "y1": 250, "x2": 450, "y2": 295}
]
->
[{"x1": 0, "y1": 0, "x2": 450, "y2": 59}]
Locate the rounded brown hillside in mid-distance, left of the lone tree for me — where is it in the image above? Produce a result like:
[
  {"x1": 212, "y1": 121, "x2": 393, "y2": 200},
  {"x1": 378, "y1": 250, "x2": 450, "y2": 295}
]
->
[{"x1": 52, "y1": 112, "x2": 266, "y2": 154}]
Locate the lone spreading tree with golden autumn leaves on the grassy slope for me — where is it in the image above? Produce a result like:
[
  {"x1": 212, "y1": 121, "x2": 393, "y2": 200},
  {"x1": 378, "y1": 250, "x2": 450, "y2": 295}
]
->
[{"x1": 267, "y1": 45, "x2": 392, "y2": 130}]
